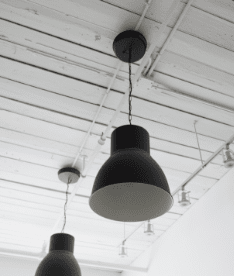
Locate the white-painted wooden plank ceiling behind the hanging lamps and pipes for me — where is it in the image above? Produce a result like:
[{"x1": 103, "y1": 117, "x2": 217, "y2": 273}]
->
[{"x1": 0, "y1": 0, "x2": 234, "y2": 270}]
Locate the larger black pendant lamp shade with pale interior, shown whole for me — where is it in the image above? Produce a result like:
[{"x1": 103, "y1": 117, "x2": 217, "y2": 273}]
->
[{"x1": 89, "y1": 125, "x2": 173, "y2": 222}]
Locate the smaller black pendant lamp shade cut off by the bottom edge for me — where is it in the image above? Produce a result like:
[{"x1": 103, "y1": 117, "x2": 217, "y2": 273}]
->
[{"x1": 35, "y1": 233, "x2": 81, "y2": 276}]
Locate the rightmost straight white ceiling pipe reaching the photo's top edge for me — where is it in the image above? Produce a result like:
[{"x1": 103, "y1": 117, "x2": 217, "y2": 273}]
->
[{"x1": 146, "y1": 0, "x2": 194, "y2": 76}]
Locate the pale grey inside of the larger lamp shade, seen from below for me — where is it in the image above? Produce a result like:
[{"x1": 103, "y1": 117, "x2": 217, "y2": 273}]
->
[{"x1": 89, "y1": 183, "x2": 174, "y2": 222}]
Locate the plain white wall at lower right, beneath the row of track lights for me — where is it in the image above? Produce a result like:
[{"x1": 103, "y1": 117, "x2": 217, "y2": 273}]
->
[{"x1": 122, "y1": 169, "x2": 234, "y2": 276}]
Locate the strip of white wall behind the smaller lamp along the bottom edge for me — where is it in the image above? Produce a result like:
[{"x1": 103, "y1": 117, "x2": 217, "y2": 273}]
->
[{"x1": 0, "y1": 256, "x2": 120, "y2": 276}]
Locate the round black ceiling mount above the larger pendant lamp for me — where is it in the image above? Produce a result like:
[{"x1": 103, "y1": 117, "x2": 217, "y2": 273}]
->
[{"x1": 113, "y1": 30, "x2": 147, "y2": 63}]
